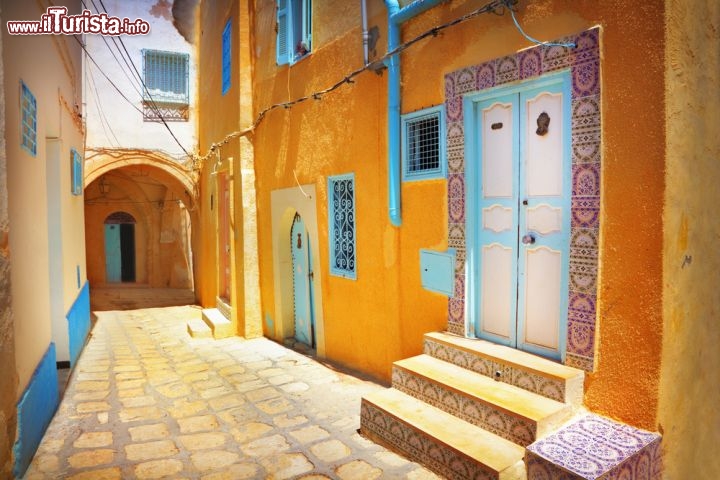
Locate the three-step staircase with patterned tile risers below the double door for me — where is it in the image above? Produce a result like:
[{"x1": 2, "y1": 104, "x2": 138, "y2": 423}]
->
[{"x1": 360, "y1": 333, "x2": 584, "y2": 479}]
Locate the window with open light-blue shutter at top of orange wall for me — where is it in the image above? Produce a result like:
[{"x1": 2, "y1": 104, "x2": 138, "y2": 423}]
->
[{"x1": 276, "y1": 0, "x2": 312, "y2": 65}]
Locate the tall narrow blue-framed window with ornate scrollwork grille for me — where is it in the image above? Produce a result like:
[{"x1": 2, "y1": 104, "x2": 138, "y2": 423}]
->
[{"x1": 328, "y1": 173, "x2": 357, "y2": 280}]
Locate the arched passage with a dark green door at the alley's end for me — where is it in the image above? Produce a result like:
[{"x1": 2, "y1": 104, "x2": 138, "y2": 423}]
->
[{"x1": 85, "y1": 152, "x2": 196, "y2": 289}]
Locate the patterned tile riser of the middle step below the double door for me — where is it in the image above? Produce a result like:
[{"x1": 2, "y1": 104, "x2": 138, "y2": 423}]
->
[{"x1": 392, "y1": 366, "x2": 537, "y2": 447}]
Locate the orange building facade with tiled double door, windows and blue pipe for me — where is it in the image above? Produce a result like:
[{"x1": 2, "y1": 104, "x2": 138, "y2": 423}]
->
[{"x1": 195, "y1": 0, "x2": 718, "y2": 478}]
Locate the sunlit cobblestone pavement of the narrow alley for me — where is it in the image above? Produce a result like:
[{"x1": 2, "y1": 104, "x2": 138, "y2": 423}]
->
[{"x1": 24, "y1": 307, "x2": 437, "y2": 480}]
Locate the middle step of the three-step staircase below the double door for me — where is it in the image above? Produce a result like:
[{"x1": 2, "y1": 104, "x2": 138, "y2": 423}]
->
[{"x1": 392, "y1": 355, "x2": 572, "y2": 447}]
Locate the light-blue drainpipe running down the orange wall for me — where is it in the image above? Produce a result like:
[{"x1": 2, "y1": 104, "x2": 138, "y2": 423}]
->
[{"x1": 385, "y1": 0, "x2": 443, "y2": 227}]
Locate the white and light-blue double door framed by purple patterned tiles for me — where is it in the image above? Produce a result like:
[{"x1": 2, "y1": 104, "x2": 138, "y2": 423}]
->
[{"x1": 466, "y1": 74, "x2": 571, "y2": 360}]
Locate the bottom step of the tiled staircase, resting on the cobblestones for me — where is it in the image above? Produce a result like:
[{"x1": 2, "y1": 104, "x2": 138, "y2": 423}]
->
[{"x1": 360, "y1": 389, "x2": 526, "y2": 480}]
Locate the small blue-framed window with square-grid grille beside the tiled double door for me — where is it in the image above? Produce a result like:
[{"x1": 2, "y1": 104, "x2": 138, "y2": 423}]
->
[{"x1": 400, "y1": 106, "x2": 447, "y2": 181}]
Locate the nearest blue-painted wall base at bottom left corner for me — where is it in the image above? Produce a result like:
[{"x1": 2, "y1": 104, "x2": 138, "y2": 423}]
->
[{"x1": 13, "y1": 343, "x2": 60, "y2": 478}]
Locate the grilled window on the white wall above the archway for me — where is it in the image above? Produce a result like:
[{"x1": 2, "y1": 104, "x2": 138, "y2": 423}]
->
[{"x1": 142, "y1": 50, "x2": 190, "y2": 122}]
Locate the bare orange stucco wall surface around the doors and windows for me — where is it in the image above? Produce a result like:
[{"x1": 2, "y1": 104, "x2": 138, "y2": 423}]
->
[{"x1": 195, "y1": 0, "x2": 665, "y2": 429}]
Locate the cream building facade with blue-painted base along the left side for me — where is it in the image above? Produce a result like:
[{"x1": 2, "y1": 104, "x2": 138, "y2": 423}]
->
[{"x1": 0, "y1": 2, "x2": 90, "y2": 477}]
